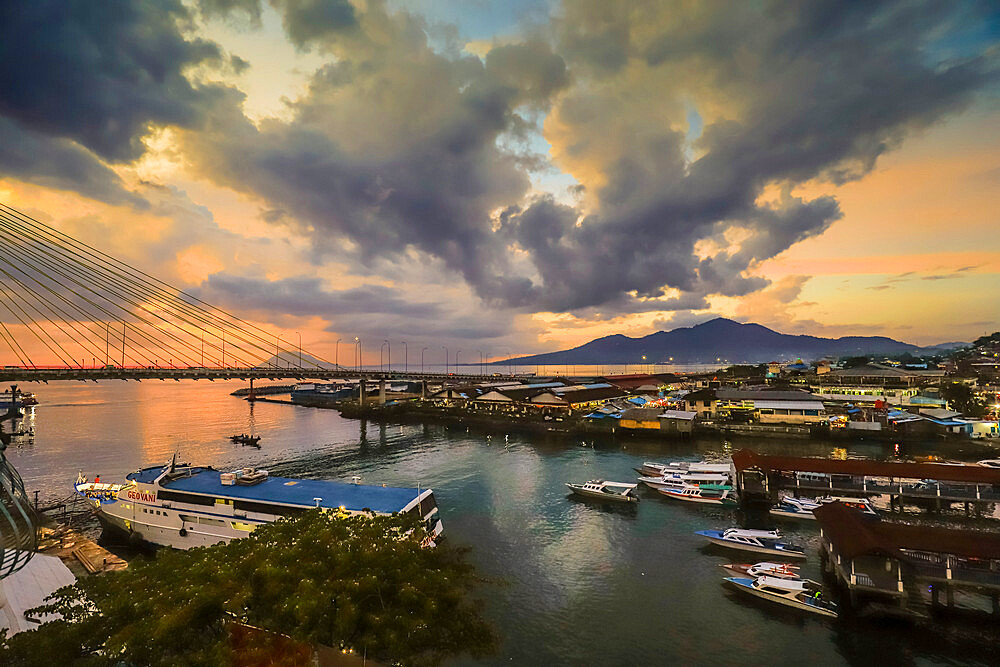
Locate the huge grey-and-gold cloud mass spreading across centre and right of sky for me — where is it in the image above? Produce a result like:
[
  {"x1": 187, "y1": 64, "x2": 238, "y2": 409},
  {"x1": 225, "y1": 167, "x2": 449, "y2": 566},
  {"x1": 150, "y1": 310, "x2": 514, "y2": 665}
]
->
[{"x1": 182, "y1": 0, "x2": 996, "y2": 320}]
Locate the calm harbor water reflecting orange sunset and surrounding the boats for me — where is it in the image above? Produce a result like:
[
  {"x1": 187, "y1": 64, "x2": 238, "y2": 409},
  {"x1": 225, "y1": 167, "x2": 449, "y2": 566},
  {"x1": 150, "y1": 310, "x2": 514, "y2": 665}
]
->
[{"x1": 8, "y1": 382, "x2": 1000, "y2": 667}]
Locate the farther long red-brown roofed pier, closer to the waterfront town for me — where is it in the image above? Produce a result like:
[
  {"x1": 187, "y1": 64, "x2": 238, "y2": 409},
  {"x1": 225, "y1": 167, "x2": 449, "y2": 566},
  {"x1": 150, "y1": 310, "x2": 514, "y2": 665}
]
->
[{"x1": 733, "y1": 449, "x2": 1000, "y2": 513}]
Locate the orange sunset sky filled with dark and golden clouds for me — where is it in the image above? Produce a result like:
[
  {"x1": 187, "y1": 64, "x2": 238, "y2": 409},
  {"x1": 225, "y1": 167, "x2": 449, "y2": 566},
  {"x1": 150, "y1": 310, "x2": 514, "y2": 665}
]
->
[{"x1": 0, "y1": 0, "x2": 1000, "y2": 361}]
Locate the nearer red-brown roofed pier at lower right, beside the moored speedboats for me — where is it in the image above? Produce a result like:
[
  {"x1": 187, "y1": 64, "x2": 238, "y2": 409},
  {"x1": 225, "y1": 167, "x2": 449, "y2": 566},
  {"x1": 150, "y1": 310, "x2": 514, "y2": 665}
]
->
[{"x1": 815, "y1": 503, "x2": 1000, "y2": 617}]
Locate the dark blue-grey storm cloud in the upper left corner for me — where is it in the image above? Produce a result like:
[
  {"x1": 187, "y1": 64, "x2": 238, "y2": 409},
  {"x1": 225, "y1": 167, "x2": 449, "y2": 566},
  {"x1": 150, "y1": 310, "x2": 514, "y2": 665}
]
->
[{"x1": 0, "y1": 0, "x2": 241, "y2": 204}]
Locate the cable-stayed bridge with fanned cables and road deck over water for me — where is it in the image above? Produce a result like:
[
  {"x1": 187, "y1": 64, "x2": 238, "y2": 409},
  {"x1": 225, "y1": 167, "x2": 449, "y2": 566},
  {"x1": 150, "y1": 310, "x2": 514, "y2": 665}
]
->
[{"x1": 0, "y1": 204, "x2": 516, "y2": 382}]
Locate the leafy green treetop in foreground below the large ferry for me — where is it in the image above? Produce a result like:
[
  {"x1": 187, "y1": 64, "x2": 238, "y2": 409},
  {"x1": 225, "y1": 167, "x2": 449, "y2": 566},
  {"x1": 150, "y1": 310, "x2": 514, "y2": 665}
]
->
[{"x1": 0, "y1": 510, "x2": 496, "y2": 666}]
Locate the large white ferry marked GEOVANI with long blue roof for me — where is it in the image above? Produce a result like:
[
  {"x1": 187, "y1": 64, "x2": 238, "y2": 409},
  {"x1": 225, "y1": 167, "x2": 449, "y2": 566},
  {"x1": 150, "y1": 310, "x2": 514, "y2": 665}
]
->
[{"x1": 75, "y1": 461, "x2": 442, "y2": 549}]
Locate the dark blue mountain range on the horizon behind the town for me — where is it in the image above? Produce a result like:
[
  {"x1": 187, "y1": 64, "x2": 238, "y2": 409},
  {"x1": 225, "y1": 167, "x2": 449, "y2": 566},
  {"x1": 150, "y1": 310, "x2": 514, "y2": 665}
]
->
[{"x1": 504, "y1": 317, "x2": 940, "y2": 365}]
